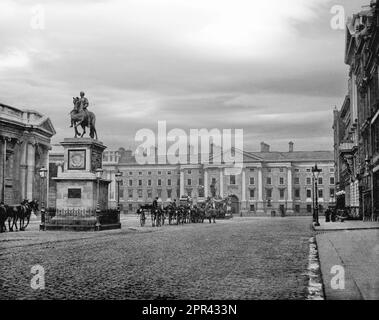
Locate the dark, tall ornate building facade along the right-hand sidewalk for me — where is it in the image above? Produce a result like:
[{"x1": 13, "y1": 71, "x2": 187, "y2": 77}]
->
[{"x1": 334, "y1": 1, "x2": 379, "y2": 219}]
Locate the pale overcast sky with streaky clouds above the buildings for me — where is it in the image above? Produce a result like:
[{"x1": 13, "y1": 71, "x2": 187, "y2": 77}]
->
[{"x1": 0, "y1": 0, "x2": 369, "y2": 151}]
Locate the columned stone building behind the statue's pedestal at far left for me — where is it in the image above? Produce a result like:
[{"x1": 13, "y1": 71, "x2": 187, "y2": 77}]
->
[{"x1": 0, "y1": 104, "x2": 55, "y2": 204}]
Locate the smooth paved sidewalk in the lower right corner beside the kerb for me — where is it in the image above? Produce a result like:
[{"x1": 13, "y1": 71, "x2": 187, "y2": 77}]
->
[{"x1": 316, "y1": 230, "x2": 379, "y2": 300}]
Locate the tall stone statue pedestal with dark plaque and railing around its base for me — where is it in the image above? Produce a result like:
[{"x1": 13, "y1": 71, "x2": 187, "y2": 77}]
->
[{"x1": 45, "y1": 138, "x2": 121, "y2": 230}]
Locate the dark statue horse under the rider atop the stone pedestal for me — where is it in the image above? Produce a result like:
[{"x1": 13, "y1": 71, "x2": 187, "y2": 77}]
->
[{"x1": 70, "y1": 97, "x2": 97, "y2": 140}]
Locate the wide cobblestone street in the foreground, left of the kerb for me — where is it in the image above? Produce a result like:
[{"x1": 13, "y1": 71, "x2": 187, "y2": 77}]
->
[{"x1": 0, "y1": 217, "x2": 311, "y2": 299}]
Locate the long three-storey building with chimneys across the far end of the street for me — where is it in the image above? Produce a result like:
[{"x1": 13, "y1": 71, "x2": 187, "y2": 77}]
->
[{"x1": 98, "y1": 142, "x2": 335, "y2": 215}]
